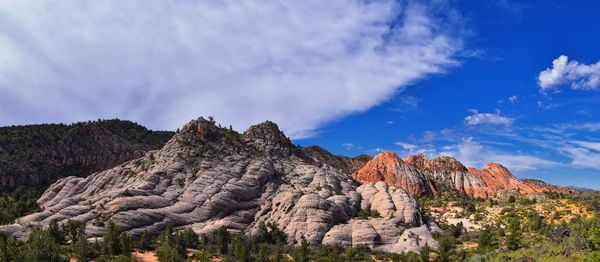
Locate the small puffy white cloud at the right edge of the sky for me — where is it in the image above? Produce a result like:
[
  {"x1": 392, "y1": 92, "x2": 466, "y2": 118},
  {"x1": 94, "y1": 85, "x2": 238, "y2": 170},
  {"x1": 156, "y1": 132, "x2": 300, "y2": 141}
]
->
[{"x1": 538, "y1": 55, "x2": 600, "y2": 90}]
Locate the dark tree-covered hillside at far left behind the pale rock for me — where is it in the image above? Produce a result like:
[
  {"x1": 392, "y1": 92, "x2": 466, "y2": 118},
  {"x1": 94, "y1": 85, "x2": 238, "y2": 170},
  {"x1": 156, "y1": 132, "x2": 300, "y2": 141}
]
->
[{"x1": 0, "y1": 120, "x2": 174, "y2": 190}]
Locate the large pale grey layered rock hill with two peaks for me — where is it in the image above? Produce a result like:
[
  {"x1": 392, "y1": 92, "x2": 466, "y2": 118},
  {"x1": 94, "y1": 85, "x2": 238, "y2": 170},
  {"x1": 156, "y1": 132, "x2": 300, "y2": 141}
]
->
[{"x1": 0, "y1": 118, "x2": 435, "y2": 253}]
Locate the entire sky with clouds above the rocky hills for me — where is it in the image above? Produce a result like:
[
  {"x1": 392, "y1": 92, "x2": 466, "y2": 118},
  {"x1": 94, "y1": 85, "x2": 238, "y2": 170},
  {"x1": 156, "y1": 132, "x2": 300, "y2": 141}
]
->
[{"x1": 0, "y1": 0, "x2": 600, "y2": 189}]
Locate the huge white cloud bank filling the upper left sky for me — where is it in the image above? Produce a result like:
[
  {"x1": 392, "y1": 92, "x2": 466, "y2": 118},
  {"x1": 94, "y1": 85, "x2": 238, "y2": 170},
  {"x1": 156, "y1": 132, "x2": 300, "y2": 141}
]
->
[{"x1": 0, "y1": 0, "x2": 462, "y2": 138}]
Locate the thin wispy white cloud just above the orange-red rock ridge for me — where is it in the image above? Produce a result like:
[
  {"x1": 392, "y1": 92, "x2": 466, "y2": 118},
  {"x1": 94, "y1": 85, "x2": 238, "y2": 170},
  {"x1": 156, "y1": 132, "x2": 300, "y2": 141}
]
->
[{"x1": 441, "y1": 137, "x2": 562, "y2": 173}]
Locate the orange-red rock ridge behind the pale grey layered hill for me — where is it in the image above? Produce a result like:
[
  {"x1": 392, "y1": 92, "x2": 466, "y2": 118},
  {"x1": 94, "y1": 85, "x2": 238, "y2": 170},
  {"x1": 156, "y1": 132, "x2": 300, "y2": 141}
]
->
[{"x1": 352, "y1": 152, "x2": 573, "y2": 198}]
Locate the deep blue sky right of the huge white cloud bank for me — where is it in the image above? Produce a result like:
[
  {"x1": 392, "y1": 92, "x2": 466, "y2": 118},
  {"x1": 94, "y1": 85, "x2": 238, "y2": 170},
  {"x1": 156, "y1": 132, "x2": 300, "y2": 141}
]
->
[{"x1": 299, "y1": 1, "x2": 600, "y2": 189}]
